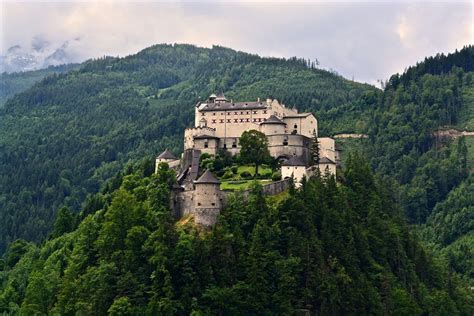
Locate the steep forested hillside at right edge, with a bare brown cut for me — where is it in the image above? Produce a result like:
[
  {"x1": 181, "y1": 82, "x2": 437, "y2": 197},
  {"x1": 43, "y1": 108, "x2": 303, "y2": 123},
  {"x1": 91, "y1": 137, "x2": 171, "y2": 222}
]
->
[{"x1": 365, "y1": 46, "x2": 474, "y2": 286}]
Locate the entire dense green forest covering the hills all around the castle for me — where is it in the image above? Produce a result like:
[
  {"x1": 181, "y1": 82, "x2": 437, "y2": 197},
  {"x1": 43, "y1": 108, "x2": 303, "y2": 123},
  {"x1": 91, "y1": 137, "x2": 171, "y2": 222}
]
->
[{"x1": 0, "y1": 45, "x2": 474, "y2": 315}]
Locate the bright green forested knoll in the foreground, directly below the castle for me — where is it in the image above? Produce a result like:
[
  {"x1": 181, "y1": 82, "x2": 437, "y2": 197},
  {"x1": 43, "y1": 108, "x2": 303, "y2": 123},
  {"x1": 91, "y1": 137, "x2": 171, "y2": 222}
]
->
[{"x1": 0, "y1": 155, "x2": 474, "y2": 315}]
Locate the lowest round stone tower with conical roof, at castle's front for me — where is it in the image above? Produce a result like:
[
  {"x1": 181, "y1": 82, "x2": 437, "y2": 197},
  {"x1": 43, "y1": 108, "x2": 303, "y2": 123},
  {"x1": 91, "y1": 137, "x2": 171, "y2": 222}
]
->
[{"x1": 194, "y1": 170, "x2": 222, "y2": 227}]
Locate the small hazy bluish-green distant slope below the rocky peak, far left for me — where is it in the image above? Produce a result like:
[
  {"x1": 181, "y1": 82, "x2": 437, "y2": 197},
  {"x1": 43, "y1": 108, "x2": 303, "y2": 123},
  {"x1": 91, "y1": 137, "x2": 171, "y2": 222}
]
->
[{"x1": 0, "y1": 64, "x2": 79, "y2": 108}]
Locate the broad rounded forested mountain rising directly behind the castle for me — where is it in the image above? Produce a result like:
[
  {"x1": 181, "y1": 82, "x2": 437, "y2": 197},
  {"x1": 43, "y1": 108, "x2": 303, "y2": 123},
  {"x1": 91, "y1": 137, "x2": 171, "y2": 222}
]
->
[{"x1": 0, "y1": 45, "x2": 379, "y2": 253}]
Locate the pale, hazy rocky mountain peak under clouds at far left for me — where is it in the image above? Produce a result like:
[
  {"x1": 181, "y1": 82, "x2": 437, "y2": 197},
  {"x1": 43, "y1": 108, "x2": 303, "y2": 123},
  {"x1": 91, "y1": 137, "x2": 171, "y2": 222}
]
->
[{"x1": 0, "y1": 37, "x2": 80, "y2": 73}]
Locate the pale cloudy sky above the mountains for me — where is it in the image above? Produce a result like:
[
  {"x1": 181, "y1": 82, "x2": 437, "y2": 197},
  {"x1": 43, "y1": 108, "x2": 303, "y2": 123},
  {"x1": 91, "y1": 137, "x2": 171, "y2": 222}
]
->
[{"x1": 0, "y1": 0, "x2": 474, "y2": 84}]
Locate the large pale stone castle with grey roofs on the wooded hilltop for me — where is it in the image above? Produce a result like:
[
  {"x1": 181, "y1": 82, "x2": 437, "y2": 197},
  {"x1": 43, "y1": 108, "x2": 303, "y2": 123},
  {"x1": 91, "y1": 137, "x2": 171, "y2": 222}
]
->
[{"x1": 156, "y1": 93, "x2": 340, "y2": 226}]
